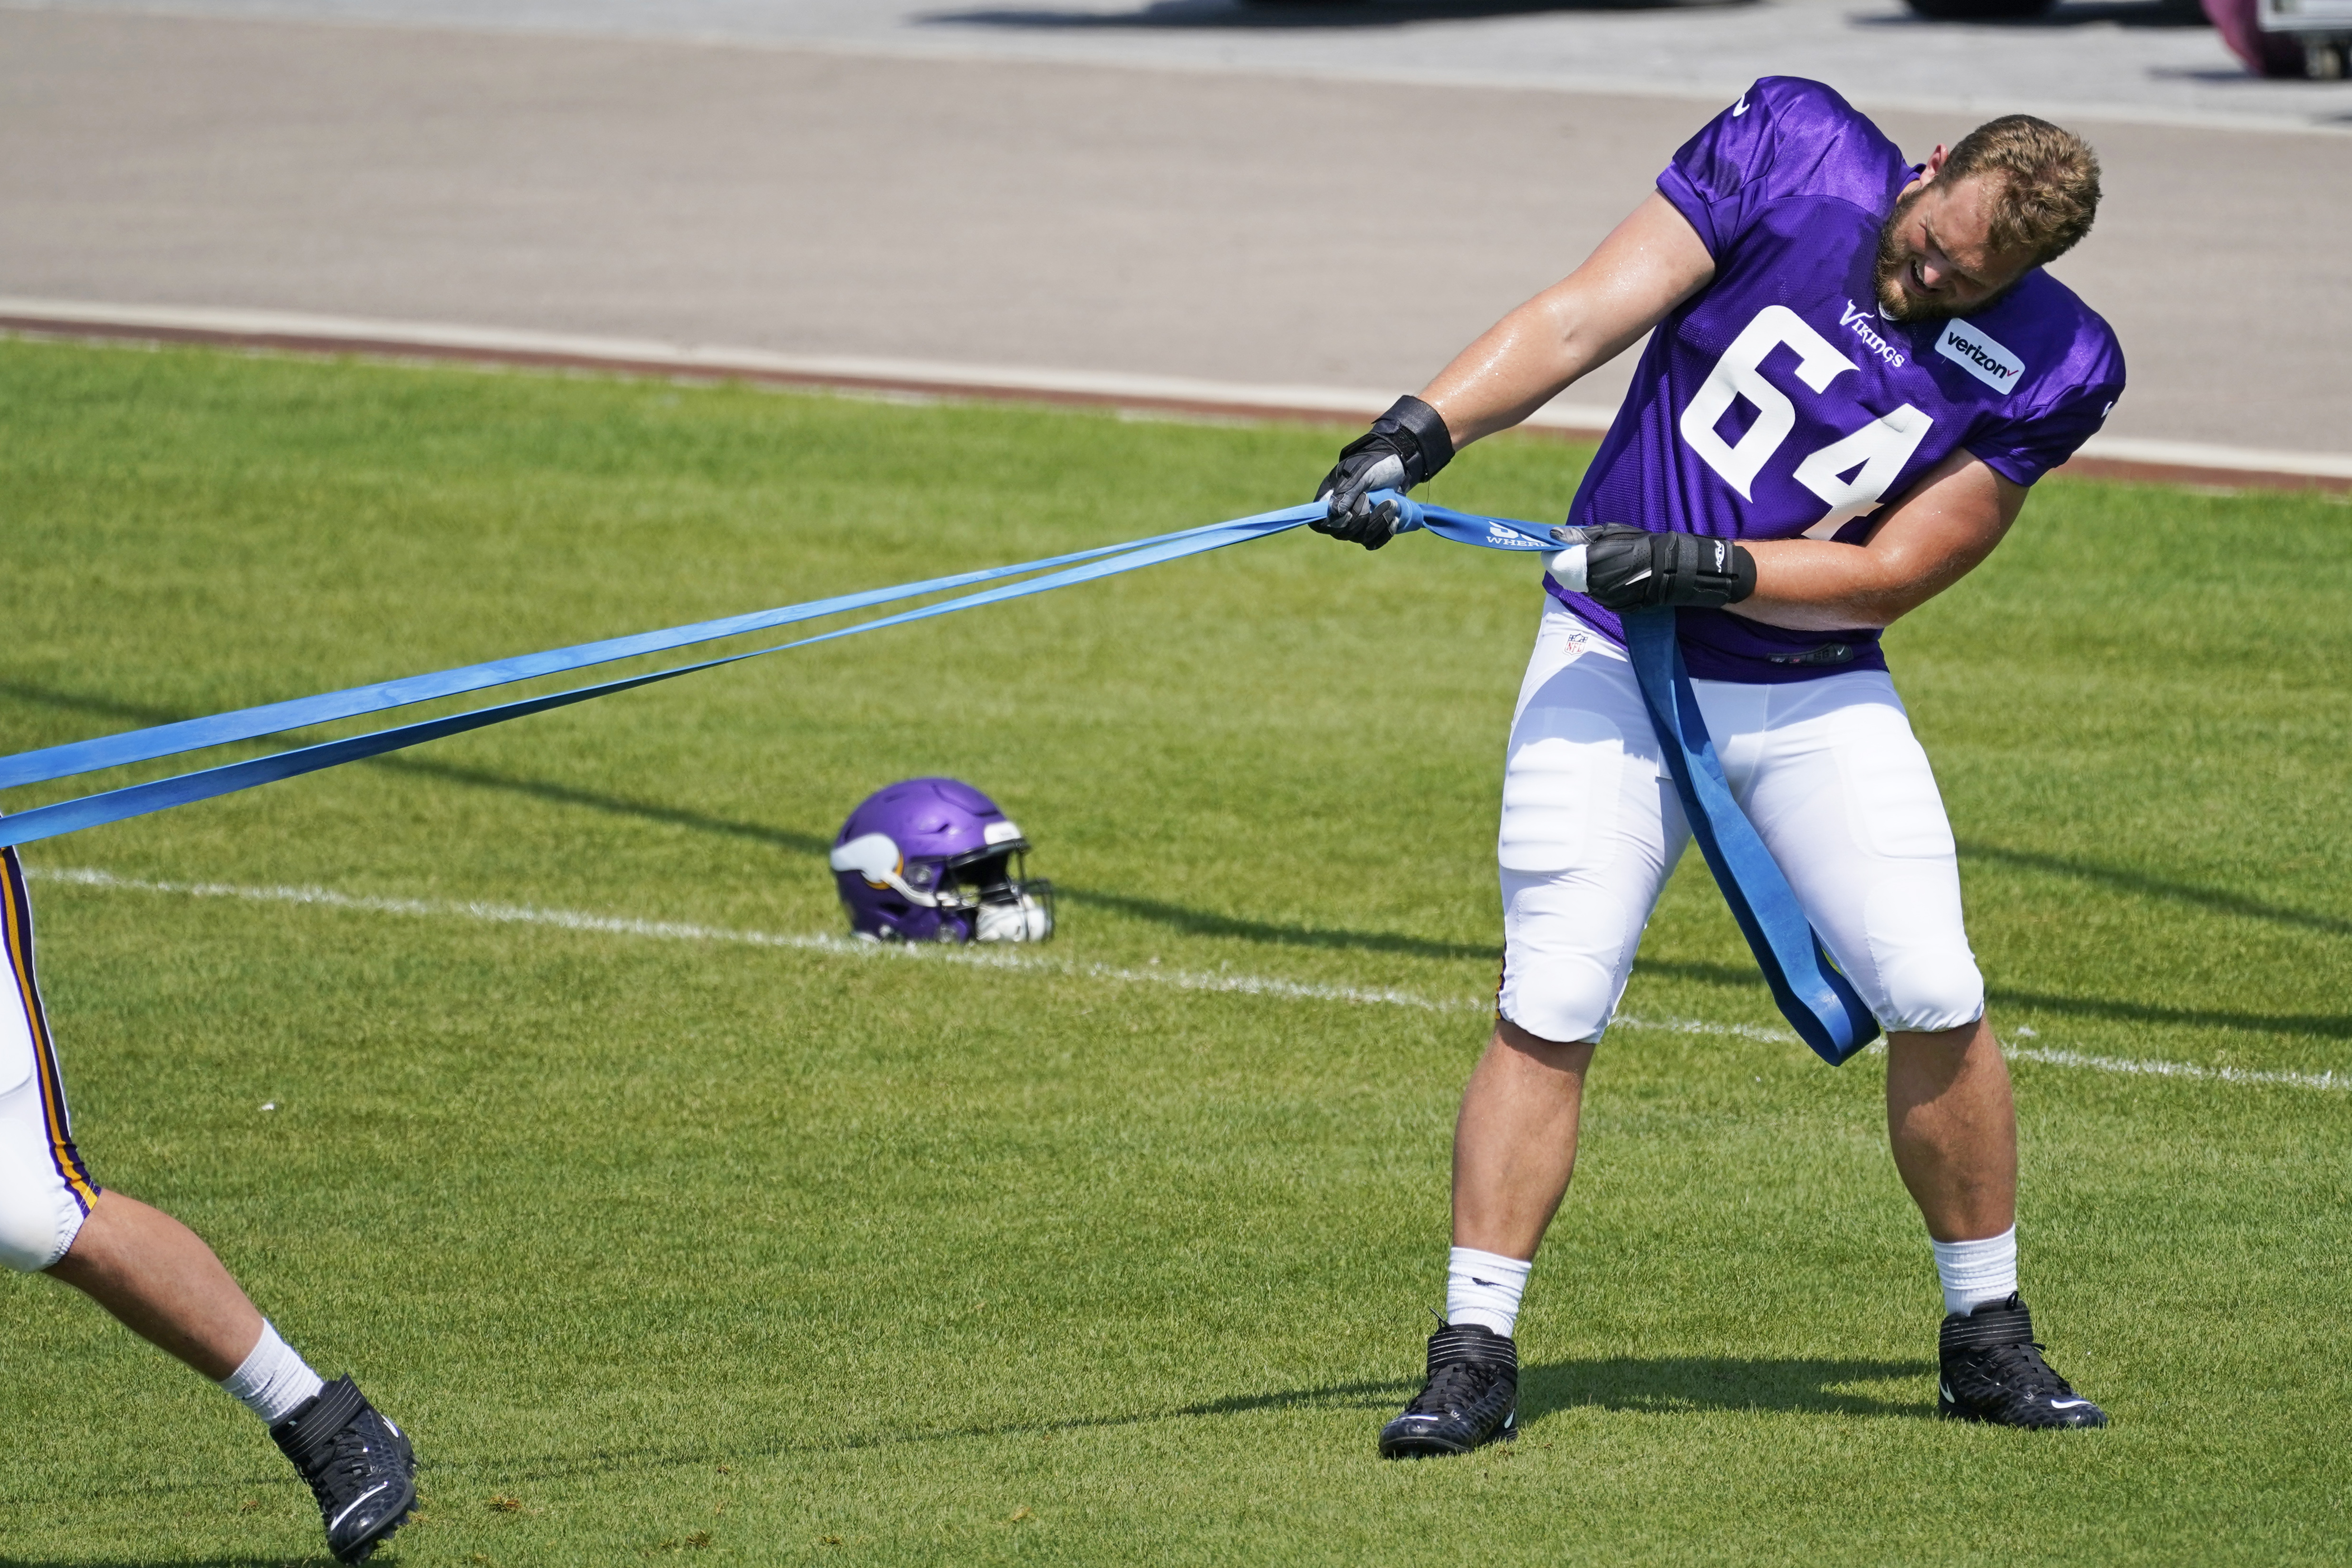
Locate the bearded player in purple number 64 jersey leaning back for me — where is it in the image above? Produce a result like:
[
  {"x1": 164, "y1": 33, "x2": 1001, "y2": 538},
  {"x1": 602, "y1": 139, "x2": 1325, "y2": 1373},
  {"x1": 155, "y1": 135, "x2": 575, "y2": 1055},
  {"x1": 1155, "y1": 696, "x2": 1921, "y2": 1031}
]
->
[{"x1": 1315, "y1": 77, "x2": 2124, "y2": 1457}]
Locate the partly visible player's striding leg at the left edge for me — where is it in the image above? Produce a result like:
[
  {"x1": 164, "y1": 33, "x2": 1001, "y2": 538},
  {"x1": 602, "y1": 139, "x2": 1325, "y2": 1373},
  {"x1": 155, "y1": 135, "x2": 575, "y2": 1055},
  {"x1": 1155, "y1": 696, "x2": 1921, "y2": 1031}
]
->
[{"x1": 0, "y1": 849, "x2": 416, "y2": 1563}]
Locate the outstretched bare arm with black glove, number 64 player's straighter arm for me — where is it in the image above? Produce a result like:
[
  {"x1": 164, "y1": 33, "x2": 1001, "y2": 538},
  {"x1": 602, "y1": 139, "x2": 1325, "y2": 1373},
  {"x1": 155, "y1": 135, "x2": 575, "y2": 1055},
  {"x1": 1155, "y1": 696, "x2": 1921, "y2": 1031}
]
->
[{"x1": 1310, "y1": 193, "x2": 1715, "y2": 550}]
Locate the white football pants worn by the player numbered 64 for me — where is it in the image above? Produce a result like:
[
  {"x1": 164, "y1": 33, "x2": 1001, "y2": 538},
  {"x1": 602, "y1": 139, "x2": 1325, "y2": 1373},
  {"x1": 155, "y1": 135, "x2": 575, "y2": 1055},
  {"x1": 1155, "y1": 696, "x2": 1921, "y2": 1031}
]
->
[{"x1": 1496, "y1": 604, "x2": 1985, "y2": 1042}]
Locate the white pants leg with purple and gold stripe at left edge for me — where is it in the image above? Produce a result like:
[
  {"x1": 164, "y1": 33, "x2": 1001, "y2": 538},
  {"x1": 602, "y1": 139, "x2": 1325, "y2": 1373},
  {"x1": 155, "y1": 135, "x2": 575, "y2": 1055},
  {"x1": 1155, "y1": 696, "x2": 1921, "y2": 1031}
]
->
[{"x1": 0, "y1": 849, "x2": 99, "y2": 1272}]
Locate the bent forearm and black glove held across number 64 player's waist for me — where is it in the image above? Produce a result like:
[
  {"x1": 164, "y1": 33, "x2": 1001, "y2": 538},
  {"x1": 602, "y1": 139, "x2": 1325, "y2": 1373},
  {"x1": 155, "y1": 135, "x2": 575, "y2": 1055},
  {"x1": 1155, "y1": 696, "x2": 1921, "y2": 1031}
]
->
[{"x1": 1552, "y1": 451, "x2": 2025, "y2": 632}]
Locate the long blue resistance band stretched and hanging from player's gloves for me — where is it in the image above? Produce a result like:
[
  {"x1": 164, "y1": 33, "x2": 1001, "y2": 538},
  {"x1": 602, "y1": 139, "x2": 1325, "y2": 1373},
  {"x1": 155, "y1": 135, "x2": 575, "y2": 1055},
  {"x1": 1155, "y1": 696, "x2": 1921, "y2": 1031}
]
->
[{"x1": 0, "y1": 491, "x2": 1877, "y2": 1065}]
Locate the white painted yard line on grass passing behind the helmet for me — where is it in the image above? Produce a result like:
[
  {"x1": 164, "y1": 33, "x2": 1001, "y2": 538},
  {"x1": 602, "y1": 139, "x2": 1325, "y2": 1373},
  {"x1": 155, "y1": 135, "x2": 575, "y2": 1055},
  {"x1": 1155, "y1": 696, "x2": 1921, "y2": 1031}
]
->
[{"x1": 26, "y1": 868, "x2": 2352, "y2": 1089}]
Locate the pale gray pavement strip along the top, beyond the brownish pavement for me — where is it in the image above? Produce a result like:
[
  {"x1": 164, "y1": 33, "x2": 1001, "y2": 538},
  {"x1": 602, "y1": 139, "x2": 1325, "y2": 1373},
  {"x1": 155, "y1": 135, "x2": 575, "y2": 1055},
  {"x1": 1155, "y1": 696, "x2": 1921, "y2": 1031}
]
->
[{"x1": 28, "y1": 0, "x2": 2352, "y2": 129}]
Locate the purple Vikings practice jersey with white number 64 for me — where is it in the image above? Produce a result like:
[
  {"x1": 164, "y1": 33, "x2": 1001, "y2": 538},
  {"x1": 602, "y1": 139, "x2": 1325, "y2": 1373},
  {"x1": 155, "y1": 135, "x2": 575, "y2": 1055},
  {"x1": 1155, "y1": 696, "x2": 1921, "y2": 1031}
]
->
[{"x1": 1545, "y1": 75, "x2": 2124, "y2": 682}]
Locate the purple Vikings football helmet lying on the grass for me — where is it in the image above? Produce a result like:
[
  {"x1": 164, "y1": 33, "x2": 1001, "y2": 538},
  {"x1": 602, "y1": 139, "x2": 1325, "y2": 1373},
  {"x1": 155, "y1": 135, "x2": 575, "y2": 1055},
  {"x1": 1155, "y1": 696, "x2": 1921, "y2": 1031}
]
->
[{"x1": 833, "y1": 778, "x2": 1054, "y2": 943}]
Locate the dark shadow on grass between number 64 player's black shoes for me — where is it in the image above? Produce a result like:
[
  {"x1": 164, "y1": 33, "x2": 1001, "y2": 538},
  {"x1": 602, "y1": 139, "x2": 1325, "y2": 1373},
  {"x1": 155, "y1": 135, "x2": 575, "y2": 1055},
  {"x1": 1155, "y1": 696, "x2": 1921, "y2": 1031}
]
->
[{"x1": 1519, "y1": 1357, "x2": 1936, "y2": 1427}]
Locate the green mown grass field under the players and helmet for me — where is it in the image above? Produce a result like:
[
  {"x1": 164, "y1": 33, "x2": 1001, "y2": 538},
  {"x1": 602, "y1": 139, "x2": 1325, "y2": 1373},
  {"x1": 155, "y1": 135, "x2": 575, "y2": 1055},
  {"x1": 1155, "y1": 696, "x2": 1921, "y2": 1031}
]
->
[{"x1": 0, "y1": 343, "x2": 2352, "y2": 1568}]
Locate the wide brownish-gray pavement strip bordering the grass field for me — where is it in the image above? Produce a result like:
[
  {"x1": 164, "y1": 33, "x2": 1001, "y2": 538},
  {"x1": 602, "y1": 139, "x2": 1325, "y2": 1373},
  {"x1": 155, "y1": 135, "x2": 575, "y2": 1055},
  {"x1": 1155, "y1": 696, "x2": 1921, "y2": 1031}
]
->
[{"x1": 0, "y1": 10, "x2": 2352, "y2": 451}]
